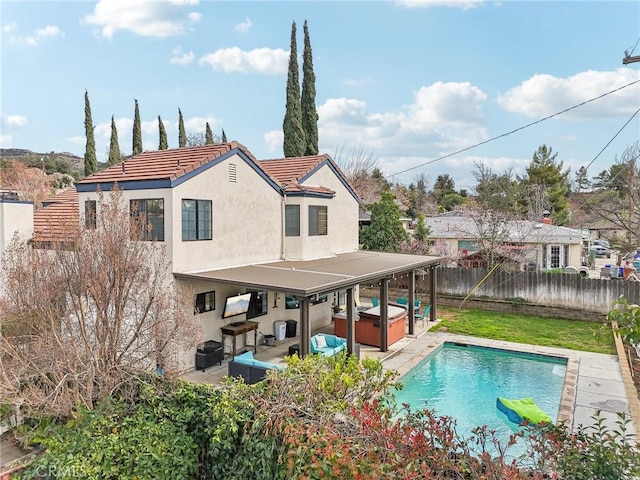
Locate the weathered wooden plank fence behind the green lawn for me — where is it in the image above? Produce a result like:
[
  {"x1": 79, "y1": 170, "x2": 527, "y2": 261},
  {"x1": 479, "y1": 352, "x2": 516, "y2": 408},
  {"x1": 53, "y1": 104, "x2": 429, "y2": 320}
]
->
[{"x1": 390, "y1": 268, "x2": 640, "y2": 315}]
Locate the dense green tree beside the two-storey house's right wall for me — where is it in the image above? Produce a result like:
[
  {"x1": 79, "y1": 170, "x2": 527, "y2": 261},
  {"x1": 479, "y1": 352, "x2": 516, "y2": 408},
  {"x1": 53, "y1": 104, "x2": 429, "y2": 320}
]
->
[{"x1": 360, "y1": 190, "x2": 409, "y2": 252}]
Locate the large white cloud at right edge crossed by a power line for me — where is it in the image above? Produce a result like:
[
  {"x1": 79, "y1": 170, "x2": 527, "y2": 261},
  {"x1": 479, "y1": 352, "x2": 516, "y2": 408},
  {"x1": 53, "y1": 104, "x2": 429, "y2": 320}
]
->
[{"x1": 498, "y1": 68, "x2": 640, "y2": 120}]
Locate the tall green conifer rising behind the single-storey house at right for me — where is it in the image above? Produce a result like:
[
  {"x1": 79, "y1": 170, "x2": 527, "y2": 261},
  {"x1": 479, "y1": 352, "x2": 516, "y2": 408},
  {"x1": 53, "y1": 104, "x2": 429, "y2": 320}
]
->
[{"x1": 519, "y1": 145, "x2": 571, "y2": 225}]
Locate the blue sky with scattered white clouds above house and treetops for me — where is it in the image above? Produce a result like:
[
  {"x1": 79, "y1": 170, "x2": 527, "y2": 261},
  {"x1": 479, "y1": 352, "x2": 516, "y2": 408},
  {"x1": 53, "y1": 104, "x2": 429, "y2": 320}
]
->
[{"x1": 0, "y1": 0, "x2": 640, "y2": 190}]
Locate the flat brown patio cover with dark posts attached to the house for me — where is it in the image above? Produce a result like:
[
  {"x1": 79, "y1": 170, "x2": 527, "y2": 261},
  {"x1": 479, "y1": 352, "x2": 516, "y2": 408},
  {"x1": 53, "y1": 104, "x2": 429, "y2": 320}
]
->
[{"x1": 174, "y1": 251, "x2": 441, "y2": 355}]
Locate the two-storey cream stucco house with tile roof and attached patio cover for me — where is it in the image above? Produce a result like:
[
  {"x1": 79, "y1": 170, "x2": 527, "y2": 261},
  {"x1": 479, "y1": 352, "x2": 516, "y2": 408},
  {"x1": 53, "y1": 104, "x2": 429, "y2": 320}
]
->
[{"x1": 26, "y1": 142, "x2": 440, "y2": 368}]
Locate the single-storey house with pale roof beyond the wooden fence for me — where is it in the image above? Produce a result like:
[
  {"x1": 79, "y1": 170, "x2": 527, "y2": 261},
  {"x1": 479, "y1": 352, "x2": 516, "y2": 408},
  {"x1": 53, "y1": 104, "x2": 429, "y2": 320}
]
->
[{"x1": 426, "y1": 215, "x2": 584, "y2": 270}]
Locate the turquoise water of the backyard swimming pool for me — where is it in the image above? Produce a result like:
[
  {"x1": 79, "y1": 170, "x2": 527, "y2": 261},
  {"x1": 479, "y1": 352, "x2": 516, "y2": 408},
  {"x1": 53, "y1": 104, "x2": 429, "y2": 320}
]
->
[{"x1": 394, "y1": 342, "x2": 567, "y2": 454}]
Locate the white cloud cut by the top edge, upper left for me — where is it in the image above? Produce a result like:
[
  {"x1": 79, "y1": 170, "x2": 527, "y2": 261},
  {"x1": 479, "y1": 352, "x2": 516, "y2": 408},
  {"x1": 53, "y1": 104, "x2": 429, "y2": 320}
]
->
[{"x1": 82, "y1": 0, "x2": 201, "y2": 38}]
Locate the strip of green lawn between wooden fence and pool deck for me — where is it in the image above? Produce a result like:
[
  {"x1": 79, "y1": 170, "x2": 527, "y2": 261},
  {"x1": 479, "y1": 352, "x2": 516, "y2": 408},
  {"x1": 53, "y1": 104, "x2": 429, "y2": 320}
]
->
[{"x1": 431, "y1": 307, "x2": 616, "y2": 355}]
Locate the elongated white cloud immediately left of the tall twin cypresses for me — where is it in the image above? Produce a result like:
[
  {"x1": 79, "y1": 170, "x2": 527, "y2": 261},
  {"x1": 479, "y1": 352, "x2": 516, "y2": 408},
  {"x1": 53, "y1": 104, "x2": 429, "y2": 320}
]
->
[{"x1": 200, "y1": 47, "x2": 289, "y2": 75}]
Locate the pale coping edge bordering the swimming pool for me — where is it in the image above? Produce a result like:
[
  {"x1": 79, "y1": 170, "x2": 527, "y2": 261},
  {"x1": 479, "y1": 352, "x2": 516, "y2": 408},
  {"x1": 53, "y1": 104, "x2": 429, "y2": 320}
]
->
[{"x1": 395, "y1": 336, "x2": 580, "y2": 429}]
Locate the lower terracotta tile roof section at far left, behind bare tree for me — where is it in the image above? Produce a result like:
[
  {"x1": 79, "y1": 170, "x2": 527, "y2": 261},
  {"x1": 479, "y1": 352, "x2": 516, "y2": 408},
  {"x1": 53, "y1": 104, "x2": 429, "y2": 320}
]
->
[{"x1": 32, "y1": 187, "x2": 80, "y2": 243}]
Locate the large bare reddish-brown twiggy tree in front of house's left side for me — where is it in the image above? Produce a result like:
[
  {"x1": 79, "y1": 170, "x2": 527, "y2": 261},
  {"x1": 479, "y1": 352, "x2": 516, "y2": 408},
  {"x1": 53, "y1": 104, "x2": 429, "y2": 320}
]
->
[{"x1": 0, "y1": 190, "x2": 200, "y2": 416}]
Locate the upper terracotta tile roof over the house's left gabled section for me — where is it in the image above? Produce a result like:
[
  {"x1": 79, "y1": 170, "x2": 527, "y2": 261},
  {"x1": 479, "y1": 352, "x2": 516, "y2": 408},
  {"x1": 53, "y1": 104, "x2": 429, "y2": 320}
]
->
[{"x1": 78, "y1": 142, "x2": 257, "y2": 185}]
